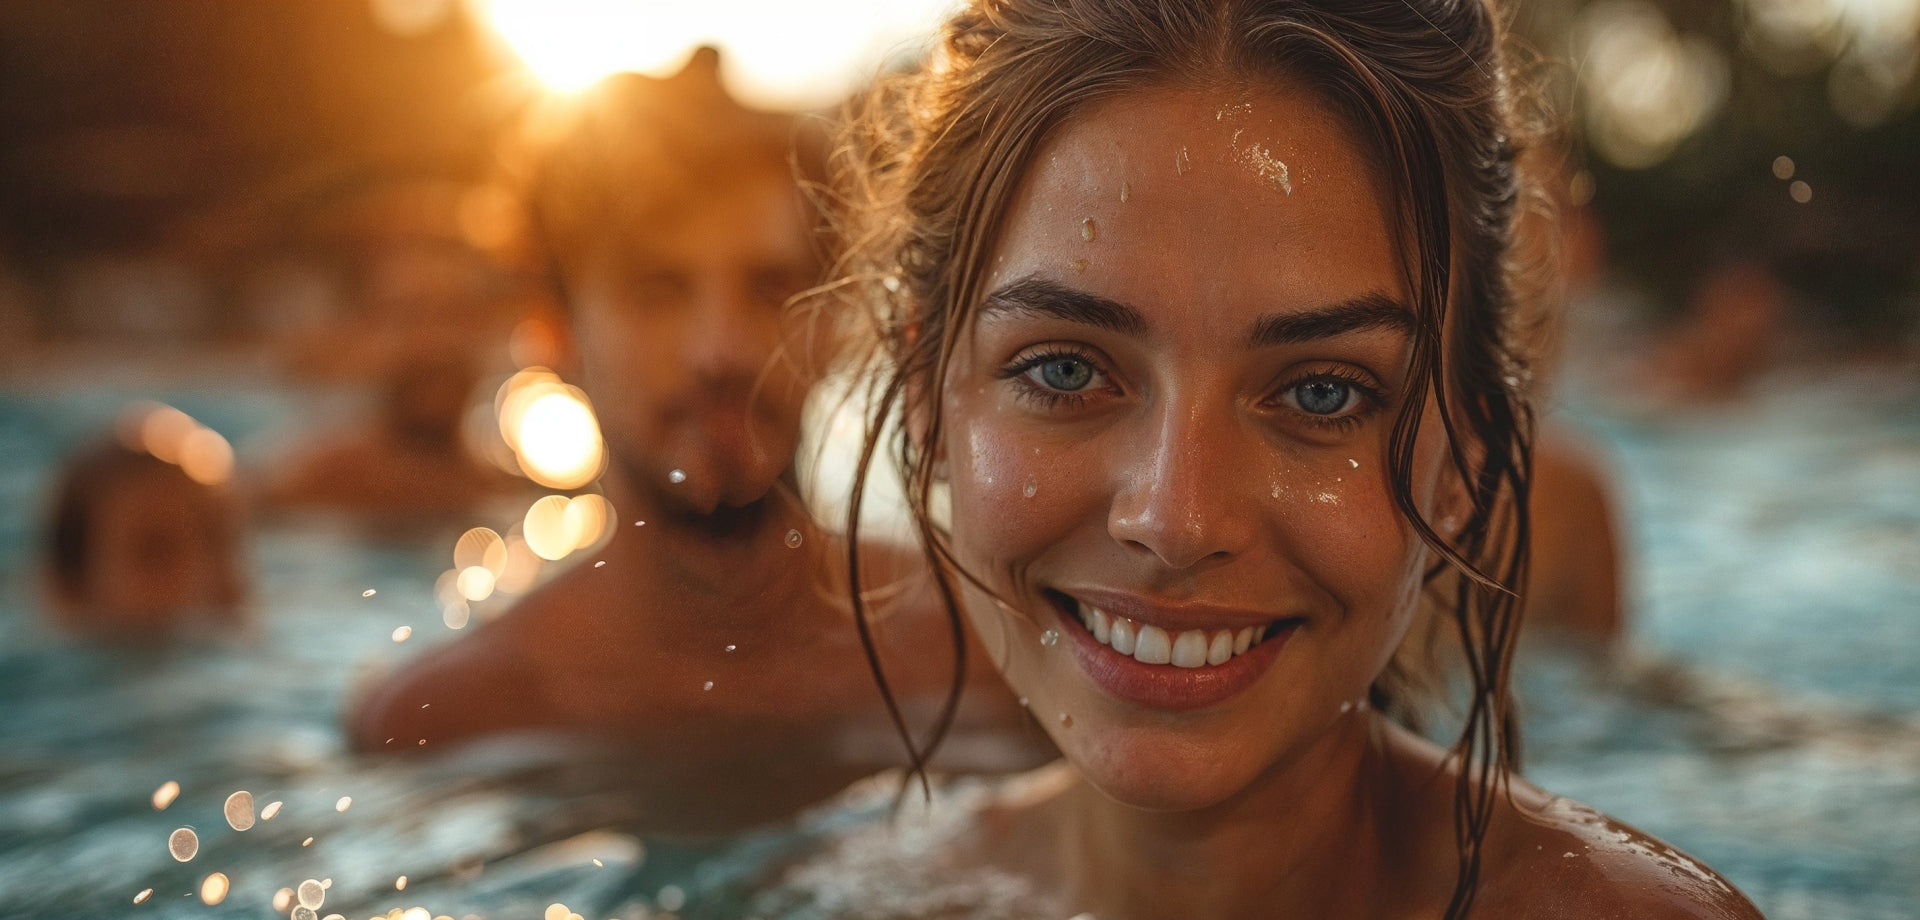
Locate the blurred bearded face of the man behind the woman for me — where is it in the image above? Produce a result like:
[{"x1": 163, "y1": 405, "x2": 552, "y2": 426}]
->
[{"x1": 572, "y1": 169, "x2": 818, "y2": 515}]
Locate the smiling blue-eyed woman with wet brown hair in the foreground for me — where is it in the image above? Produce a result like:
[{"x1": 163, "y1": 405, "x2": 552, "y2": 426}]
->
[{"x1": 829, "y1": 0, "x2": 1757, "y2": 918}]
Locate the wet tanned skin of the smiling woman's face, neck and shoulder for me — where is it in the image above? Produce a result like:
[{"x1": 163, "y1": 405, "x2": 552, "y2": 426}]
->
[{"x1": 937, "y1": 86, "x2": 1751, "y2": 918}]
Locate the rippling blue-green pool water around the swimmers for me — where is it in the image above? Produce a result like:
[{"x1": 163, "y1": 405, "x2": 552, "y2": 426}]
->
[{"x1": 0, "y1": 368, "x2": 1920, "y2": 920}]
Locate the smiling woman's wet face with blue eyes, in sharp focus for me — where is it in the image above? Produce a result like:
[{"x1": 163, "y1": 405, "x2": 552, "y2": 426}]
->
[{"x1": 937, "y1": 88, "x2": 1457, "y2": 809}]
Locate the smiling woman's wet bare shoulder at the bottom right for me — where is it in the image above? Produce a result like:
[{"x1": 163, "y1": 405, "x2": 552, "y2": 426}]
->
[{"x1": 1475, "y1": 782, "x2": 1761, "y2": 920}]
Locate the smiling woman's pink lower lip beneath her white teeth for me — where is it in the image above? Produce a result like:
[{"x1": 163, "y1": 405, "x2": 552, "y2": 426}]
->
[{"x1": 1048, "y1": 605, "x2": 1300, "y2": 713}]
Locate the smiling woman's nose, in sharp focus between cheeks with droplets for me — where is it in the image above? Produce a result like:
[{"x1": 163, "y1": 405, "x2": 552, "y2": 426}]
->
[{"x1": 1106, "y1": 405, "x2": 1260, "y2": 570}]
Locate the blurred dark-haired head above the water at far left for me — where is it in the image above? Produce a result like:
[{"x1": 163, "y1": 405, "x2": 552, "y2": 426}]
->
[{"x1": 44, "y1": 407, "x2": 248, "y2": 643}]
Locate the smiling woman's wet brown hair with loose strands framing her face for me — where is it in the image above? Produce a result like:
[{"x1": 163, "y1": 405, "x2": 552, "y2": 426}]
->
[{"x1": 837, "y1": 0, "x2": 1532, "y2": 918}]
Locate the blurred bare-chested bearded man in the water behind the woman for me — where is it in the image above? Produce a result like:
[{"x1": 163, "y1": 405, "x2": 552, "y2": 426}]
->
[{"x1": 349, "y1": 50, "x2": 1050, "y2": 828}]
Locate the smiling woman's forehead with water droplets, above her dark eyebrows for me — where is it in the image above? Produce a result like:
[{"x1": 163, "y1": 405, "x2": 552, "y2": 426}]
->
[{"x1": 983, "y1": 86, "x2": 1405, "y2": 334}]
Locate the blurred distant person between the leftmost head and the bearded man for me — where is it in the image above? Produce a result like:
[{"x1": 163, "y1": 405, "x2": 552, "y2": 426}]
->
[{"x1": 261, "y1": 344, "x2": 520, "y2": 521}]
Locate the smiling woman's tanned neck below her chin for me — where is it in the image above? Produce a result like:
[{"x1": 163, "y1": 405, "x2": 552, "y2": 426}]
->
[{"x1": 1056, "y1": 714, "x2": 1430, "y2": 920}]
